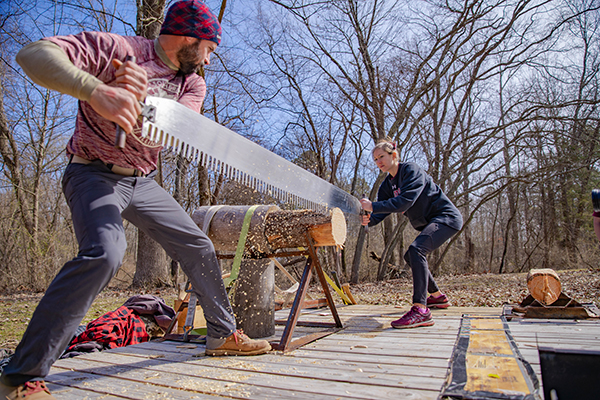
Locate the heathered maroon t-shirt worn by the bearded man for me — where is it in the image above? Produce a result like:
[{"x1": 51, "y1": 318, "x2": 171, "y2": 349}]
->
[{"x1": 44, "y1": 32, "x2": 206, "y2": 173}]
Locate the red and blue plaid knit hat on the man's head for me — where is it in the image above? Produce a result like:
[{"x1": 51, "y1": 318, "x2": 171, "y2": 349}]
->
[{"x1": 160, "y1": 0, "x2": 221, "y2": 44}]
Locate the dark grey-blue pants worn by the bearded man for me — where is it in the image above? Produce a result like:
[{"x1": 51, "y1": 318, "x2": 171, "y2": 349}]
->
[{"x1": 2, "y1": 161, "x2": 236, "y2": 386}]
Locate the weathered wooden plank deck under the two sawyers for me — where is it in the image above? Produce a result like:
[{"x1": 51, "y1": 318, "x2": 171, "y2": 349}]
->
[{"x1": 46, "y1": 305, "x2": 600, "y2": 400}]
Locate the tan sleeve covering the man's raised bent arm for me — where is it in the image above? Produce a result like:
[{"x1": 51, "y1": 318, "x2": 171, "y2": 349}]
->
[{"x1": 16, "y1": 40, "x2": 102, "y2": 101}]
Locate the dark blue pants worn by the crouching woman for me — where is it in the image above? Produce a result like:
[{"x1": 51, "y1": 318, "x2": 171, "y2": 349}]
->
[{"x1": 404, "y1": 222, "x2": 458, "y2": 305}]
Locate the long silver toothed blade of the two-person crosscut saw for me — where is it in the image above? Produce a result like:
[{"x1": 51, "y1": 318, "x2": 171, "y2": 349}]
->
[{"x1": 142, "y1": 96, "x2": 361, "y2": 215}]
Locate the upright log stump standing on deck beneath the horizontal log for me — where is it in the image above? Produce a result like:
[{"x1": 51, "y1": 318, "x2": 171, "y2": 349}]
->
[{"x1": 231, "y1": 258, "x2": 275, "y2": 338}]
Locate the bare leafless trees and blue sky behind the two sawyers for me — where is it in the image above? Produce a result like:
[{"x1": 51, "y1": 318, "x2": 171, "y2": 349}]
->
[{"x1": 0, "y1": 0, "x2": 600, "y2": 293}]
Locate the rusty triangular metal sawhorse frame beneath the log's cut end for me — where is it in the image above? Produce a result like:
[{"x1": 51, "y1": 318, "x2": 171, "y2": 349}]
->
[{"x1": 271, "y1": 232, "x2": 344, "y2": 352}]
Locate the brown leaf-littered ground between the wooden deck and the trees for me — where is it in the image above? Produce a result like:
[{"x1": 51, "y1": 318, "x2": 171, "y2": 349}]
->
[{"x1": 0, "y1": 269, "x2": 600, "y2": 350}]
